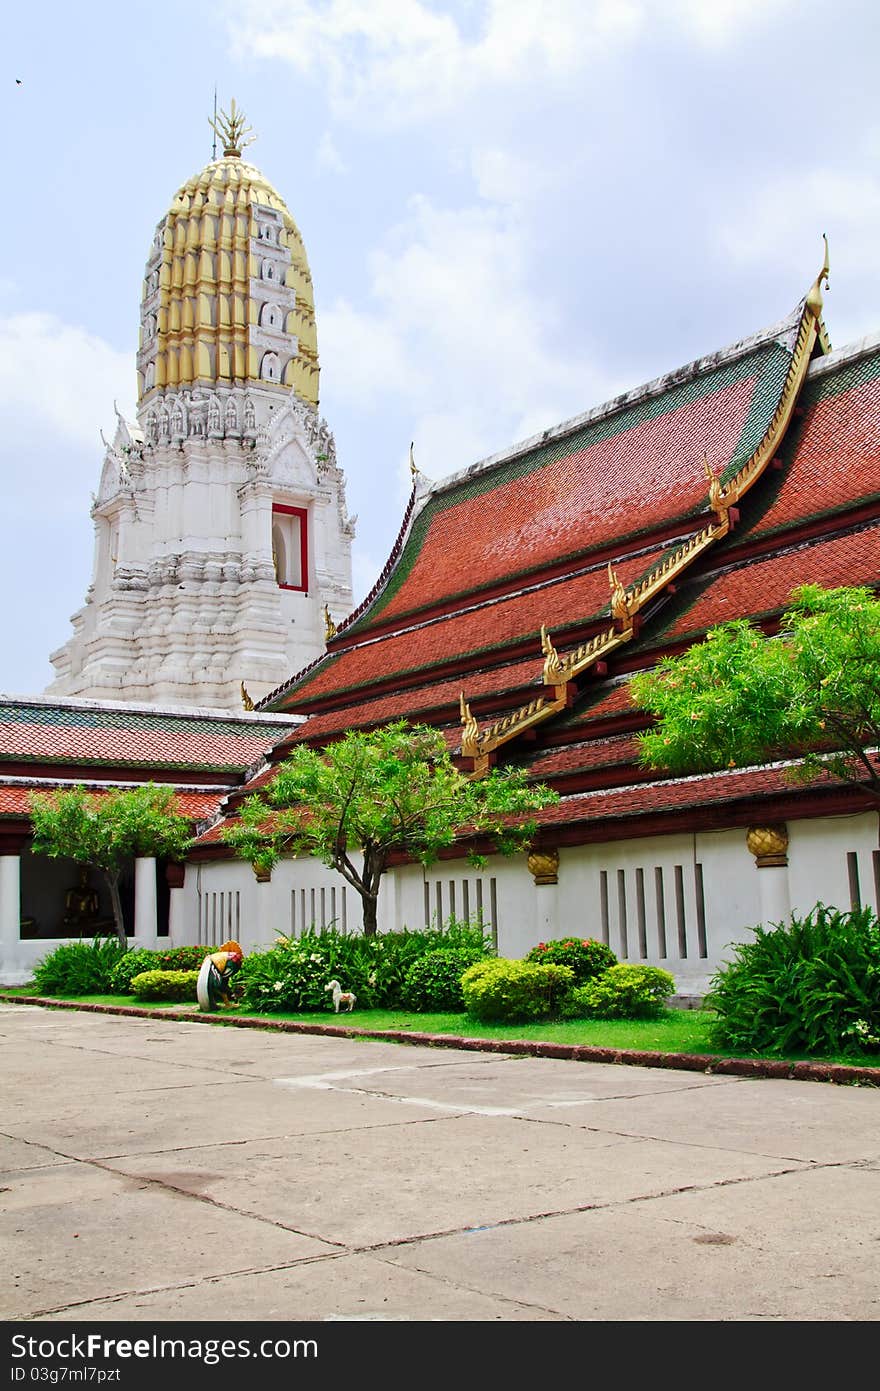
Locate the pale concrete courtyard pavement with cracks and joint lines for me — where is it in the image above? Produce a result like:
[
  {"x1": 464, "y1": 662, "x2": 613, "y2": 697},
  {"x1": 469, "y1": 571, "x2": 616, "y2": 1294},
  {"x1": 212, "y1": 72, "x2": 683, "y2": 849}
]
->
[{"x1": 0, "y1": 1004, "x2": 880, "y2": 1321}]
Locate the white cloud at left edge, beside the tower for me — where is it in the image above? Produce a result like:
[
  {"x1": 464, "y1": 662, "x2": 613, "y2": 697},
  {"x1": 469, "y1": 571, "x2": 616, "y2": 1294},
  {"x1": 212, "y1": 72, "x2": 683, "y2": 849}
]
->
[{"x1": 0, "y1": 313, "x2": 135, "y2": 456}]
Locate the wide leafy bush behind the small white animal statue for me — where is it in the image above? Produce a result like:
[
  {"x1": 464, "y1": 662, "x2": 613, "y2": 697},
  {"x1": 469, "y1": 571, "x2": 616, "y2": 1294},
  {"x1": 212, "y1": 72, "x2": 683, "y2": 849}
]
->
[{"x1": 236, "y1": 918, "x2": 491, "y2": 1014}]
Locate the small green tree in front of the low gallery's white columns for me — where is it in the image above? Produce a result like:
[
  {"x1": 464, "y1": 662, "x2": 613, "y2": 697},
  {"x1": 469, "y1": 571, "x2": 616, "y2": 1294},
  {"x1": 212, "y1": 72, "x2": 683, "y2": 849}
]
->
[{"x1": 31, "y1": 783, "x2": 192, "y2": 946}]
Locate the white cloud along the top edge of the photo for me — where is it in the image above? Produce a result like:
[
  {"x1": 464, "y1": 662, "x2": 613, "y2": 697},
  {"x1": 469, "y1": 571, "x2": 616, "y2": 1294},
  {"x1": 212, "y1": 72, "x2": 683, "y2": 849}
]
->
[{"x1": 229, "y1": 0, "x2": 794, "y2": 125}]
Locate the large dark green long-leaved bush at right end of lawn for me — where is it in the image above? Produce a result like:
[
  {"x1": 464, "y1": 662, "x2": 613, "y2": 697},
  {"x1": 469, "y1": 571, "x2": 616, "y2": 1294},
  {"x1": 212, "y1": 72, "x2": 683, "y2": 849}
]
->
[{"x1": 706, "y1": 903, "x2": 880, "y2": 1056}]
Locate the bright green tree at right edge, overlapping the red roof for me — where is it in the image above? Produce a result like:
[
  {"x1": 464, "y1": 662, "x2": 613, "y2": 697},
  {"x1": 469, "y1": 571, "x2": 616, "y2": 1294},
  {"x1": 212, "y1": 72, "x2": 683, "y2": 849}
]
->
[{"x1": 631, "y1": 584, "x2": 880, "y2": 798}]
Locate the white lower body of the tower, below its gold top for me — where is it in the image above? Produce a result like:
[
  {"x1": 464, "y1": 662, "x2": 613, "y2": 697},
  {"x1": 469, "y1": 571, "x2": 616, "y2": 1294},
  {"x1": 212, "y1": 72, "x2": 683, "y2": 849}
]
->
[{"x1": 47, "y1": 383, "x2": 355, "y2": 709}]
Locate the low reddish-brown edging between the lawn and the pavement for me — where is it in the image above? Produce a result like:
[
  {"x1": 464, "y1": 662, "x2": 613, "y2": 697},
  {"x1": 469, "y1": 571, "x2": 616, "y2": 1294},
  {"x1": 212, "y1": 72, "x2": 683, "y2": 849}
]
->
[{"x1": 0, "y1": 992, "x2": 880, "y2": 1086}]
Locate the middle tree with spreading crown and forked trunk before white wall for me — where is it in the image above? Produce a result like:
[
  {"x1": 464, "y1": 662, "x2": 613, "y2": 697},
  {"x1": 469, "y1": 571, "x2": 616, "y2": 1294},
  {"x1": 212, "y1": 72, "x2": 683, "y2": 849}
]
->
[{"x1": 222, "y1": 721, "x2": 559, "y2": 935}]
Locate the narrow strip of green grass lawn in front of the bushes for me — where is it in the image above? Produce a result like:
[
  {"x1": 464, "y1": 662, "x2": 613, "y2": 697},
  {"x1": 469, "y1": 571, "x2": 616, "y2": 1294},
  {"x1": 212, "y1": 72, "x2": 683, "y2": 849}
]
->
[{"x1": 0, "y1": 986, "x2": 880, "y2": 1068}]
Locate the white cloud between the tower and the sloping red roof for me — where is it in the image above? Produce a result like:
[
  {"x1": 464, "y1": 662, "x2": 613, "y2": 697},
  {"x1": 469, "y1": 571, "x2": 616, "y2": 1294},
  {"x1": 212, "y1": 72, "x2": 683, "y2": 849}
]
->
[{"x1": 320, "y1": 198, "x2": 620, "y2": 479}]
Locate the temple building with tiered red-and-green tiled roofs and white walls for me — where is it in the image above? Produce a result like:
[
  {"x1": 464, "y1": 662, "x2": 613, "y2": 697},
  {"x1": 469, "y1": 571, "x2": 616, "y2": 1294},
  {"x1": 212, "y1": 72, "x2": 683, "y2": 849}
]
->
[{"x1": 0, "y1": 211, "x2": 880, "y2": 997}]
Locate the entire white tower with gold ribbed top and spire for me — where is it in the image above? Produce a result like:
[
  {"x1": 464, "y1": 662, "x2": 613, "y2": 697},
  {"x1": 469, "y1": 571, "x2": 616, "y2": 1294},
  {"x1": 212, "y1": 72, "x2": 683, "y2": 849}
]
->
[{"x1": 49, "y1": 103, "x2": 355, "y2": 709}]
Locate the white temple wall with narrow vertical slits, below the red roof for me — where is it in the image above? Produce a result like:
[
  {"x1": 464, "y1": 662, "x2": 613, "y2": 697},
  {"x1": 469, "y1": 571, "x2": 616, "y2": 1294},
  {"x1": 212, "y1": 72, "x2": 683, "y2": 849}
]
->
[{"x1": 0, "y1": 814, "x2": 880, "y2": 995}]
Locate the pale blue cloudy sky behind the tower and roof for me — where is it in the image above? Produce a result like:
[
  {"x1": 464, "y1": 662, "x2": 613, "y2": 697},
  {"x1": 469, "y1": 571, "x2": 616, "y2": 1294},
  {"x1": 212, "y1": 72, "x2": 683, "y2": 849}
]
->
[{"x1": 0, "y1": 0, "x2": 880, "y2": 694}]
